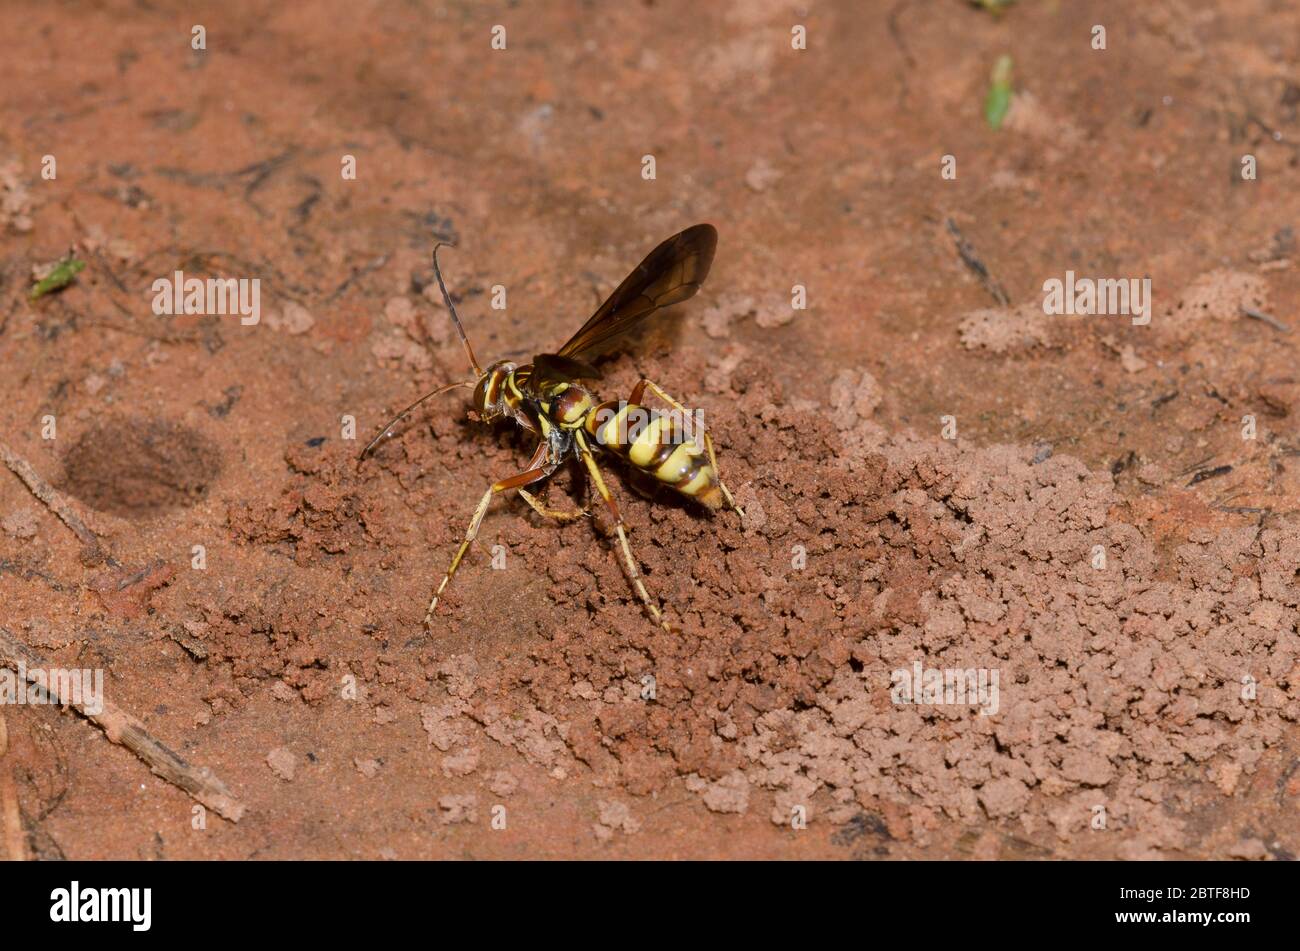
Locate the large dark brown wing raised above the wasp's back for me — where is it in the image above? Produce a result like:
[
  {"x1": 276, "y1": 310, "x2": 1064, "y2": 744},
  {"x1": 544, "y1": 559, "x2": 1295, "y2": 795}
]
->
[{"x1": 559, "y1": 225, "x2": 718, "y2": 356}]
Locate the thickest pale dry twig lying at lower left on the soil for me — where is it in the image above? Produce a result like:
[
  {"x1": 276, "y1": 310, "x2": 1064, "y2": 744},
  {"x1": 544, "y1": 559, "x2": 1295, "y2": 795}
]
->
[{"x1": 0, "y1": 628, "x2": 244, "y2": 822}]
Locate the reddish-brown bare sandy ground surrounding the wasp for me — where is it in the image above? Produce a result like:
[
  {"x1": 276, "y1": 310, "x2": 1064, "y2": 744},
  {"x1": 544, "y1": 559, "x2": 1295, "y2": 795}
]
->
[{"x1": 0, "y1": 0, "x2": 1300, "y2": 859}]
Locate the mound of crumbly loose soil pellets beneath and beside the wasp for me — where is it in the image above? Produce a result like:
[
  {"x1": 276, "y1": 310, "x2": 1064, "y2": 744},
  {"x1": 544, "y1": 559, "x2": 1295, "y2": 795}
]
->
[{"x1": 185, "y1": 353, "x2": 1300, "y2": 856}]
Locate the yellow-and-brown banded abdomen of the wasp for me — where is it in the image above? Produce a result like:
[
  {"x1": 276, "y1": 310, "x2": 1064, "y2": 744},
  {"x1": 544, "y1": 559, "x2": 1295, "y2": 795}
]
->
[{"x1": 584, "y1": 400, "x2": 723, "y2": 508}]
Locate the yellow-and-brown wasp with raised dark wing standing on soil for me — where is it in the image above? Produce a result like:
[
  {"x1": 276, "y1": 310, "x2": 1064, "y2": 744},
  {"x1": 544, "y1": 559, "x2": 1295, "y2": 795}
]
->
[{"x1": 358, "y1": 225, "x2": 745, "y2": 630}]
